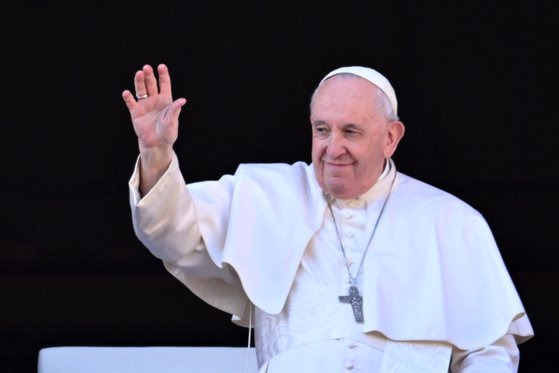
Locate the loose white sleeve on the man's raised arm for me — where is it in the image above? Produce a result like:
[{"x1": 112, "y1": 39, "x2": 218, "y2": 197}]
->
[{"x1": 129, "y1": 155, "x2": 246, "y2": 316}]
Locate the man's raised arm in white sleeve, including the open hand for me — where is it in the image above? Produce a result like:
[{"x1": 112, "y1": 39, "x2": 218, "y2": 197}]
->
[{"x1": 127, "y1": 65, "x2": 249, "y2": 317}]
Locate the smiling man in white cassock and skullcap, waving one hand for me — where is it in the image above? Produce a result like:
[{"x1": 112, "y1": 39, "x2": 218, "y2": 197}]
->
[{"x1": 123, "y1": 65, "x2": 533, "y2": 372}]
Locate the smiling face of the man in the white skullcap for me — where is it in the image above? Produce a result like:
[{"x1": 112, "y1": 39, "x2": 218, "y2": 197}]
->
[{"x1": 311, "y1": 76, "x2": 403, "y2": 199}]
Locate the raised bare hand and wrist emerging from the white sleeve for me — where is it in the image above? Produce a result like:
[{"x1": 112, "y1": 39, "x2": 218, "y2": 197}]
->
[{"x1": 122, "y1": 64, "x2": 186, "y2": 194}]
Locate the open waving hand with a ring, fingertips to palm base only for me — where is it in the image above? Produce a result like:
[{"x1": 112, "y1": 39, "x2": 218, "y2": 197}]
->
[{"x1": 122, "y1": 64, "x2": 186, "y2": 152}]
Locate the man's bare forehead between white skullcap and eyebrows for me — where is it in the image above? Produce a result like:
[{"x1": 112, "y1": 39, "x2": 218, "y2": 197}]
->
[{"x1": 311, "y1": 74, "x2": 379, "y2": 120}]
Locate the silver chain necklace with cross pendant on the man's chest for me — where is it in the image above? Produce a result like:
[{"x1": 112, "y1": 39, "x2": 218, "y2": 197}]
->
[{"x1": 328, "y1": 171, "x2": 397, "y2": 323}]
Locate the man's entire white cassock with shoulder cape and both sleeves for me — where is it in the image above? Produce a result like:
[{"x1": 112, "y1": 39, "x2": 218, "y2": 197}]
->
[{"x1": 130, "y1": 153, "x2": 533, "y2": 372}]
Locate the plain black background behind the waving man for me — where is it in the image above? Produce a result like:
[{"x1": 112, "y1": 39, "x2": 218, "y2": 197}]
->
[{"x1": 0, "y1": 0, "x2": 559, "y2": 372}]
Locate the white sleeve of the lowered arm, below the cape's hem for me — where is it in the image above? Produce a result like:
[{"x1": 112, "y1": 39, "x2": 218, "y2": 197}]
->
[{"x1": 450, "y1": 334, "x2": 520, "y2": 373}]
